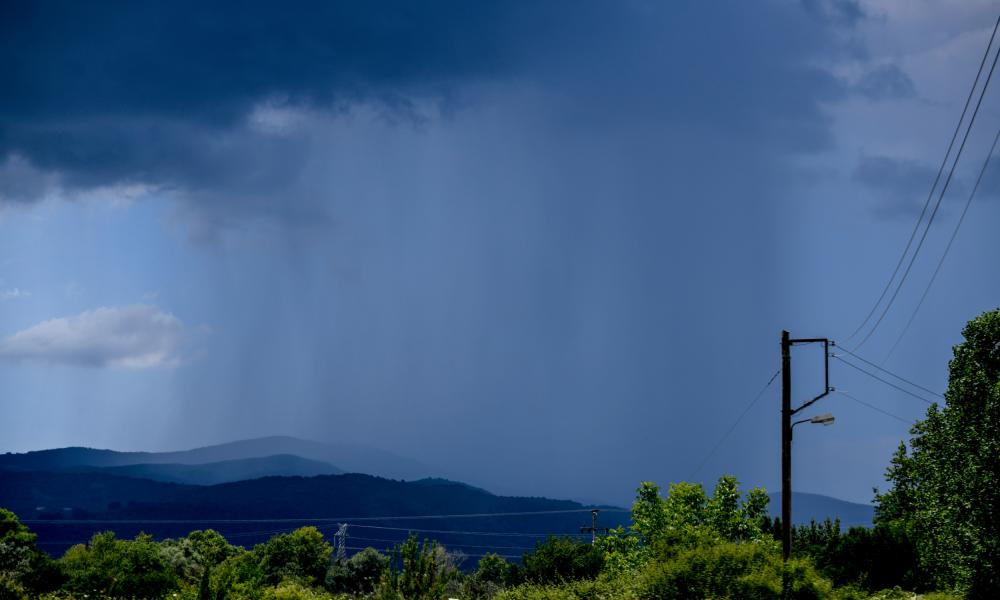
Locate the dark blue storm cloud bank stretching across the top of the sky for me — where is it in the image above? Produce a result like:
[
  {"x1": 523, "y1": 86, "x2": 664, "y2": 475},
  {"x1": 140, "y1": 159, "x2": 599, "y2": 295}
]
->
[{"x1": 0, "y1": 0, "x2": 860, "y2": 222}]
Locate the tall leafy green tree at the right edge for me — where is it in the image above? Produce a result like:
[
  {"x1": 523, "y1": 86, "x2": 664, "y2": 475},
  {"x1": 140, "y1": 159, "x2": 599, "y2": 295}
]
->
[{"x1": 877, "y1": 309, "x2": 1000, "y2": 600}]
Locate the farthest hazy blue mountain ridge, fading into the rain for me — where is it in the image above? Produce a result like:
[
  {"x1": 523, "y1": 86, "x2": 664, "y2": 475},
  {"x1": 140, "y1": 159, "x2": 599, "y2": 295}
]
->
[{"x1": 0, "y1": 436, "x2": 437, "y2": 480}]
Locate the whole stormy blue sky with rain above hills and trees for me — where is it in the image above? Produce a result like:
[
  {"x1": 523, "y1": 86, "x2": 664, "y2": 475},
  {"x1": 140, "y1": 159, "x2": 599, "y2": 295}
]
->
[{"x1": 0, "y1": 0, "x2": 1000, "y2": 504}]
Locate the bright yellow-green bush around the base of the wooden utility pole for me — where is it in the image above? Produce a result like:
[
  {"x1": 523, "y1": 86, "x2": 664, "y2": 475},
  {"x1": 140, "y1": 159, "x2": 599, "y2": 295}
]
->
[{"x1": 637, "y1": 542, "x2": 833, "y2": 600}]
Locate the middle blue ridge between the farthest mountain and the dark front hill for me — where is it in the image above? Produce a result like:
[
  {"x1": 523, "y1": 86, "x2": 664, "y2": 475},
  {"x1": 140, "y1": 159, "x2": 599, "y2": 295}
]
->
[{"x1": 66, "y1": 454, "x2": 343, "y2": 485}]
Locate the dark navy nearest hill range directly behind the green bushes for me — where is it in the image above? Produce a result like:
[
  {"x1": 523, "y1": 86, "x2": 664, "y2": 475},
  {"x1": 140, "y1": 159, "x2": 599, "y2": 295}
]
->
[{"x1": 0, "y1": 470, "x2": 628, "y2": 557}]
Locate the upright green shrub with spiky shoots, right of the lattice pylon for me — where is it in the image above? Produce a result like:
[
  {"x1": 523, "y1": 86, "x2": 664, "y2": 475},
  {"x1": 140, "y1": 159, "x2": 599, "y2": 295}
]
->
[{"x1": 376, "y1": 535, "x2": 458, "y2": 600}]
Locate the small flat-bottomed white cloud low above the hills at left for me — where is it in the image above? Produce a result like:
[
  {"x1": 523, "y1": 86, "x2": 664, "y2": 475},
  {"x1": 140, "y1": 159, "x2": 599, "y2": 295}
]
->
[{"x1": 0, "y1": 304, "x2": 186, "y2": 368}]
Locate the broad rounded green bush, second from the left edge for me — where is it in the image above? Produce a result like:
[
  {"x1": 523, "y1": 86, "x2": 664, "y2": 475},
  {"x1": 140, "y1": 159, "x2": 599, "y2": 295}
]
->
[{"x1": 60, "y1": 531, "x2": 177, "y2": 598}]
